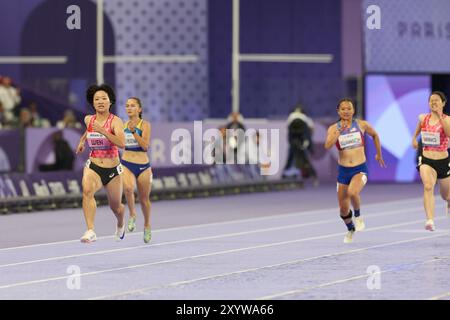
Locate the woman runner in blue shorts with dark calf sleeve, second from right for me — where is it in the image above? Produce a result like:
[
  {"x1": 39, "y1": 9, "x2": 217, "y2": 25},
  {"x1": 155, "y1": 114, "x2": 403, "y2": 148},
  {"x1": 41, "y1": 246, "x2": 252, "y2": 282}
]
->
[{"x1": 325, "y1": 99, "x2": 386, "y2": 243}]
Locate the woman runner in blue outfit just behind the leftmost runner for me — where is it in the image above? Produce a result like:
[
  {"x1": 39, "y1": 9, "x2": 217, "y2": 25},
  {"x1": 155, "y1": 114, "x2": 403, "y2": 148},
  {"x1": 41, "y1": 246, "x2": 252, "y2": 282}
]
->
[{"x1": 122, "y1": 97, "x2": 153, "y2": 243}]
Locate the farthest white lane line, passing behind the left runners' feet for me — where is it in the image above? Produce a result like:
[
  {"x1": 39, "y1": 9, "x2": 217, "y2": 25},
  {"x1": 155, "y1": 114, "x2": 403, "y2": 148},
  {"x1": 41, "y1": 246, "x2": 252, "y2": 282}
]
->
[{"x1": 0, "y1": 198, "x2": 426, "y2": 252}]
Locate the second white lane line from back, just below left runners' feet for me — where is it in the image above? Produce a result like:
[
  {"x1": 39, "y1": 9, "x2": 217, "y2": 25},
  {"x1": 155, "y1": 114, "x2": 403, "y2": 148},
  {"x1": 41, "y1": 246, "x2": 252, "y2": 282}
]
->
[{"x1": 0, "y1": 208, "x2": 423, "y2": 268}]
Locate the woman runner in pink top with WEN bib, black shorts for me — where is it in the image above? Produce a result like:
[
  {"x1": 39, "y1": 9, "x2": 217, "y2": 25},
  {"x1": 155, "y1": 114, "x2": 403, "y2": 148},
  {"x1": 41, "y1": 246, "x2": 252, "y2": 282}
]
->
[{"x1": 77, "y1": 84, "x2": 125, "y2": 243}]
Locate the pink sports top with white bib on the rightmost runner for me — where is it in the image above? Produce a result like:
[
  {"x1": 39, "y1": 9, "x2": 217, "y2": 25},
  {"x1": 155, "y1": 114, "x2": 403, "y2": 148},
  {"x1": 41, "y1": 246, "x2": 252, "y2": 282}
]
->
[{"x1": 420, "y1": 113, "x2": 448, "y2": 151}]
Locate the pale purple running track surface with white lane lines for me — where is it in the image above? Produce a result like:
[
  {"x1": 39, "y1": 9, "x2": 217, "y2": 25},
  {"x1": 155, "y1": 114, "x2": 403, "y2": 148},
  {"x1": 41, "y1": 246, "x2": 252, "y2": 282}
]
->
[{"x1": 0, "y1": 184, "x2": 450, "y2": 300}]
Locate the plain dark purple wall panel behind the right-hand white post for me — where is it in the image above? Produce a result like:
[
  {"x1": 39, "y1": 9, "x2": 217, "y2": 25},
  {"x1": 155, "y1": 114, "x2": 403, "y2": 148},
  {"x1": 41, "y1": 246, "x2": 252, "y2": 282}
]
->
[{"x1": 209, "y1": 0, "x2": 343, "y2": 117}]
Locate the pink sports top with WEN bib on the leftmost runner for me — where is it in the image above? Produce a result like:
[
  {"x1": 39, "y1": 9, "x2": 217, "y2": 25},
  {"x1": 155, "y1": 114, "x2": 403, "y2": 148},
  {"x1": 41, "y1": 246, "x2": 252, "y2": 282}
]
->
[{"x1": 87, "y1": 113, "x2": 119, "y2": 158}]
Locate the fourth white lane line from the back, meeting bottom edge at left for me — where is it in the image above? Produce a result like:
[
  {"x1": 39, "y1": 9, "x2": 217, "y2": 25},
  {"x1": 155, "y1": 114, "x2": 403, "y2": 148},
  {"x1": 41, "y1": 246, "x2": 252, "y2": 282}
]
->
[{"x1": 88, "y1": 232, "x2": 450, "y2": 300}]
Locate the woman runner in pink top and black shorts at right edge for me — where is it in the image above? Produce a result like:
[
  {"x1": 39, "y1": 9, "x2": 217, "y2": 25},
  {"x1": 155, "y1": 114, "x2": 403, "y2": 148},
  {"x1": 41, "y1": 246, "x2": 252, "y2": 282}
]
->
[{"x1": 412, "y1": 91, "x2": 450, "y2": 231}]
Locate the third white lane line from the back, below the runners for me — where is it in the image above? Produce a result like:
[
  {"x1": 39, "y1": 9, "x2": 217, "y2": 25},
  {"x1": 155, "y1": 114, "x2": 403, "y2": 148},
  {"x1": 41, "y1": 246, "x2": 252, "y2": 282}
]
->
[{"x1": 0, "y1": 218, "x2": 444, "y2": 289}]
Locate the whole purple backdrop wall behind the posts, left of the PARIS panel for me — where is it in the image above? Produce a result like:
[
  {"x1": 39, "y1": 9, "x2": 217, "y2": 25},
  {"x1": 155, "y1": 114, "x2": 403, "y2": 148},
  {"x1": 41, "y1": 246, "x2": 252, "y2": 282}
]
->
[{"x1": 0, "y1": 0, "x2": 343, "y2": 121}]
